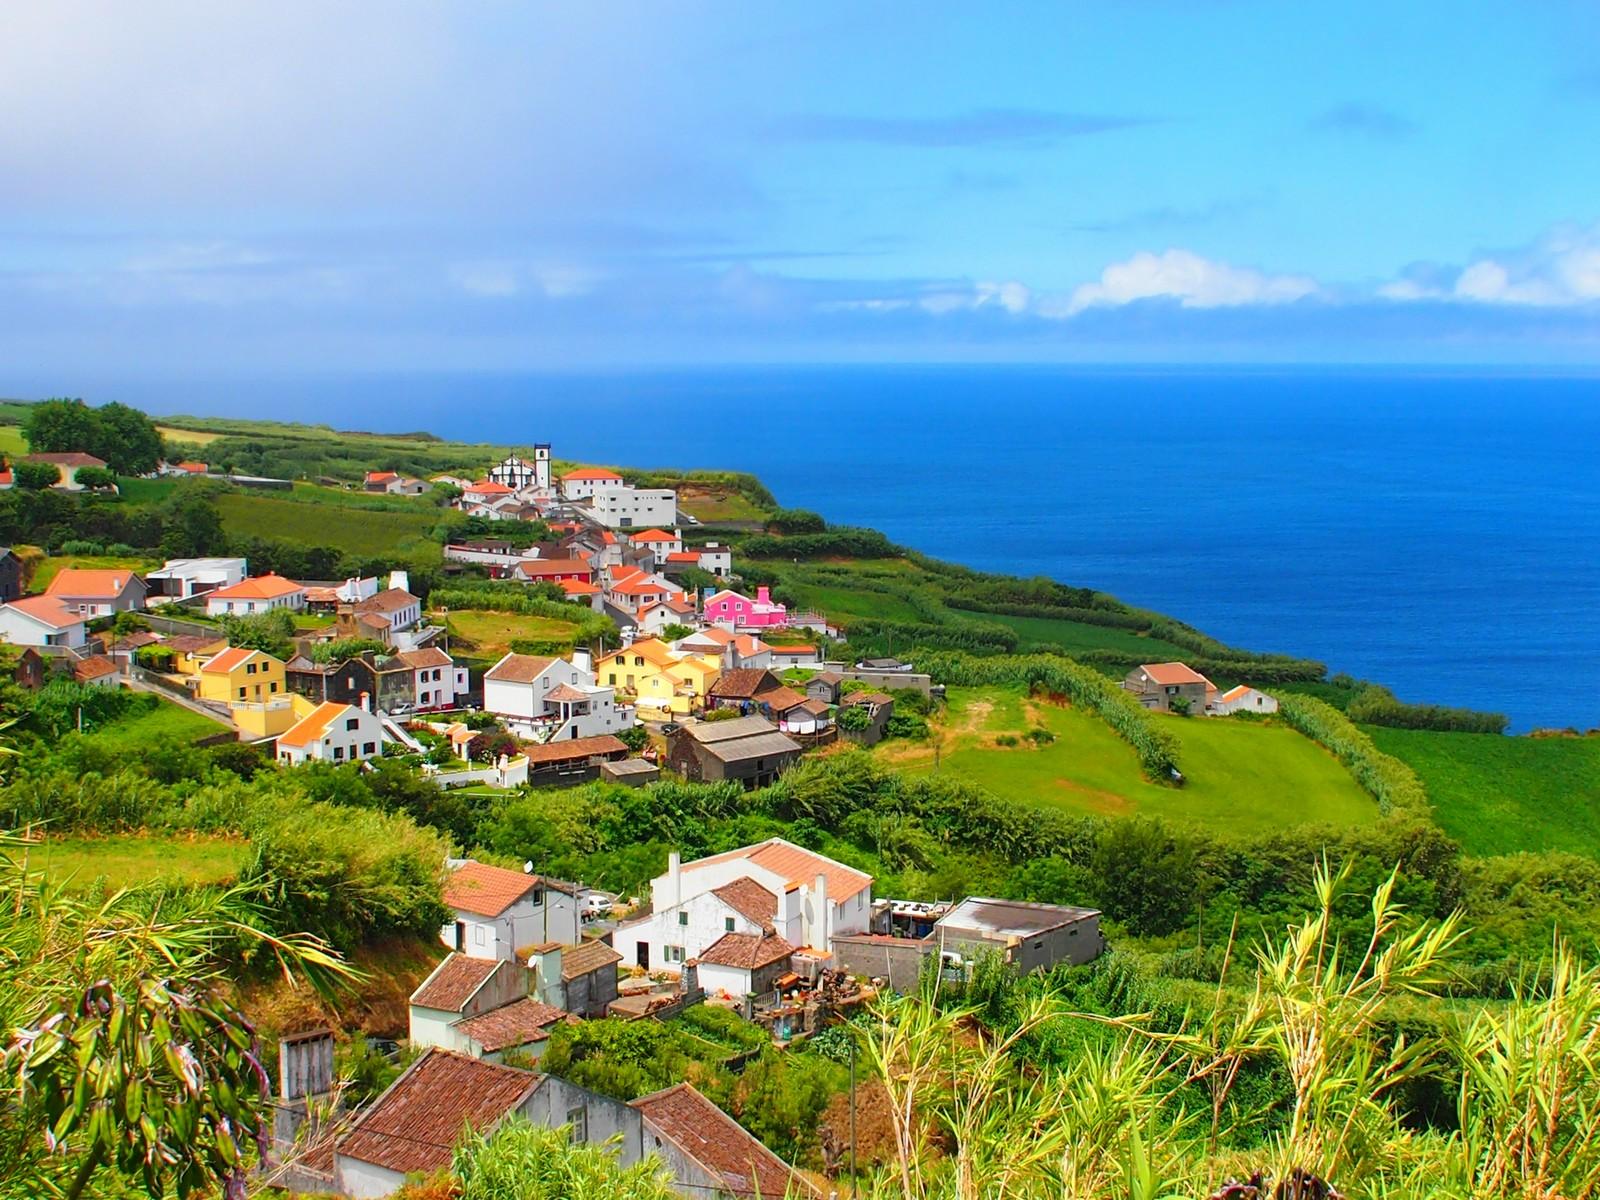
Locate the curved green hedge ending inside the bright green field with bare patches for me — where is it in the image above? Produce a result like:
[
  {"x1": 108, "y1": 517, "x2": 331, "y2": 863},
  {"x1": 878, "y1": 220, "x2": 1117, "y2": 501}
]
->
[{"x1": 917, "y1": 651, "x2": 1178, "y2": 782}]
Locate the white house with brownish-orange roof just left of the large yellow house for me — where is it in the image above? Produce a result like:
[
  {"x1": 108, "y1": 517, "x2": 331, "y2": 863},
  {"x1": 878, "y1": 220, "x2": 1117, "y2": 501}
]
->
[{"x1": 483, "y1": 653, "x2": 634, "y2": 742}]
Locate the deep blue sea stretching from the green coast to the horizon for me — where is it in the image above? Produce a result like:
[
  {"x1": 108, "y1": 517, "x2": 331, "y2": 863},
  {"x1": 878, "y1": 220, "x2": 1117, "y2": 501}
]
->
[{"x1": 34, "y1": 366, "x2": 1600, "y2": 730}]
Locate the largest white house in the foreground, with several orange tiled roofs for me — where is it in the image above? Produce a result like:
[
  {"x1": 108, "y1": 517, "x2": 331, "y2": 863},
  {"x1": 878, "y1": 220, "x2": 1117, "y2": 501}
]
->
[{"x1": 613, "y1": 838, "x2": 872, "y2": 995}]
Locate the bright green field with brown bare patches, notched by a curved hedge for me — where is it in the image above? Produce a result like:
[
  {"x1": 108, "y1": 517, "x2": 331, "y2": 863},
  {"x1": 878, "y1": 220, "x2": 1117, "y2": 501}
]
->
[{"x1": 878, "y1": 688, "x2": 1378, "y2": 834}]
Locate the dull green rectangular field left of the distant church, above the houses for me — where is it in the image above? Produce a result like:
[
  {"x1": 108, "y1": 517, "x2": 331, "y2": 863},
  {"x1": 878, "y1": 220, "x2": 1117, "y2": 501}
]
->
[{"x1": 216, "y1": 491, "x2": 445, "y2": 558}]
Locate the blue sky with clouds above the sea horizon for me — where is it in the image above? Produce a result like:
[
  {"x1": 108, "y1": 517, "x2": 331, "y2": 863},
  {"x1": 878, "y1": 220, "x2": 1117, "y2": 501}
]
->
[{"x1": 0, "y1": 0, "x2": 1600, "y2": 371}]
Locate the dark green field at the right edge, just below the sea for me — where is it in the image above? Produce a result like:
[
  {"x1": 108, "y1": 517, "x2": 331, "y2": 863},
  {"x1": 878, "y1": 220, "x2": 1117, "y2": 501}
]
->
[{"x1": 1363, "y1": 726, "x2": 1600, "y2": 856}]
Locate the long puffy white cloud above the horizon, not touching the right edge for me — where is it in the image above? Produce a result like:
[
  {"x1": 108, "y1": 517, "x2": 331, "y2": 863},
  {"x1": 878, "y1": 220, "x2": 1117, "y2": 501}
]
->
[{"x1": 1062, "y1": 250, "x2": 1317, "y2": 317}]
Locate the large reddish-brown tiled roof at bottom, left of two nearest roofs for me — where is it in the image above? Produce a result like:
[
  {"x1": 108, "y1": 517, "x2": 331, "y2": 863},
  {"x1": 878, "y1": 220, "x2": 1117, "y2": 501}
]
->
[{"x1": 336, "y1": 1046, "x2": 542, "y2": 1174}]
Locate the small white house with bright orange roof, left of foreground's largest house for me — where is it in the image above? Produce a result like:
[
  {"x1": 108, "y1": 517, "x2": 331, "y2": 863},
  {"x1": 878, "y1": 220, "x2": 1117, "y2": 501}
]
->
[{"x1": 438, "y1": 859, "x2": 582, "y2": 966}]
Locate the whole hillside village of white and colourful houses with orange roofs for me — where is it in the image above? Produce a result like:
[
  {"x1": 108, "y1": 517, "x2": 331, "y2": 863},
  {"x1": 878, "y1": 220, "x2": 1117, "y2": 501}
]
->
[{"x1": 0, "y1": 445, "x2": 1152, "y2": 1197}]
